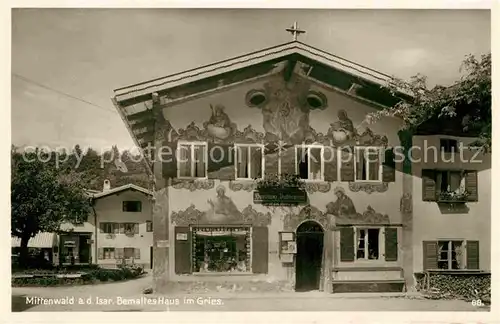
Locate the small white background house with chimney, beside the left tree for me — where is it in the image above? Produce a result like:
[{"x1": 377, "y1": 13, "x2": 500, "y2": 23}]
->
[{"x1": 60, "y1": 181, "x2": 153, "y2": 268}]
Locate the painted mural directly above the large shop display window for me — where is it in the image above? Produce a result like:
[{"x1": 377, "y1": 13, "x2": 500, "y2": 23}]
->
[{"x1": 171, "y1": 185, "x2": 271, "y2": 226}]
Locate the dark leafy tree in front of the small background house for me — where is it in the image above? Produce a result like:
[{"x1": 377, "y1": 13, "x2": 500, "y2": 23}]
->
[{"x1": 11, "y1": 150, "x2": 91, "y2": 265}]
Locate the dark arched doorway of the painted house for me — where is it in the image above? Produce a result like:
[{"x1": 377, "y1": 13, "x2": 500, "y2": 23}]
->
[{"x1": 295, "y1": 221, "x2": 323, "y2": 291}]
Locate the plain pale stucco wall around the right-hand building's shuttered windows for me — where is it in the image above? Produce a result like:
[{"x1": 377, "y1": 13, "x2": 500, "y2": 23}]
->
[{"x1": 412, "y1": 135, "x2": 491, "y2": 272}]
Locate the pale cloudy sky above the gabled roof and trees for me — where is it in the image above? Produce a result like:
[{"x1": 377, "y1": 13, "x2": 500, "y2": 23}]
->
[{"x1": 11, "y1": 9, "x2": 491, "y2": 150}]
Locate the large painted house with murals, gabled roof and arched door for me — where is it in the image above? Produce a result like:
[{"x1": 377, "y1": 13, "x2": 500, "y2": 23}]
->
[{"x1": 113, "y1": 41, "x2": 428, "y2": 292}]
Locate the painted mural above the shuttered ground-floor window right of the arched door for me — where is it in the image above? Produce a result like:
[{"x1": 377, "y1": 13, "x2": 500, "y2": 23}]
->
[{"x1": 326, "y1": 187, "x2": 390, "y2": 225}]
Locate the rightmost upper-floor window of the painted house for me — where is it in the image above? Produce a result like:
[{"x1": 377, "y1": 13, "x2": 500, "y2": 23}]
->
[{"x1": 354, "y1": 147, "x2": 382, "y2": 181}]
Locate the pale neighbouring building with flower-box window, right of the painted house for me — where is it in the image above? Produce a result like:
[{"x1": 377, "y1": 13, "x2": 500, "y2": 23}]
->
[{"x1": 412, "y1": 122, "x2": 491, "y2": 273}]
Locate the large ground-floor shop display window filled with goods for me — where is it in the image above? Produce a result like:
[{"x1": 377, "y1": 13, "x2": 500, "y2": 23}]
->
[{"x1": 192, "y1": 227, "x2": 250, "y2": 273}]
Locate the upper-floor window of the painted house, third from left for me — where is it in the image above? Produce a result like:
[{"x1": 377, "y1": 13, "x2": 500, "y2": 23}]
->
[{"x1": 295, "y1": 145, "x2": 324, "y2": 180}]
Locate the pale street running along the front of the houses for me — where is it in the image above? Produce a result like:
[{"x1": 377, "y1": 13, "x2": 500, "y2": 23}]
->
[{"x1": 12, "y1": 276, "x2": 487, "y2": 312}]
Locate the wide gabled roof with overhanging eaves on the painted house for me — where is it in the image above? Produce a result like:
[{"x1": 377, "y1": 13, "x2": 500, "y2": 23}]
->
[{"x1": 112, "y1": 41, "x2": 407, "y2": 170}]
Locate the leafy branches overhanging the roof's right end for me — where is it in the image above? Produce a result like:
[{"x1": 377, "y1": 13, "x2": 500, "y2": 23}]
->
[{"x1": 371, "y1": 54, "x2": 491, "y2": 150}]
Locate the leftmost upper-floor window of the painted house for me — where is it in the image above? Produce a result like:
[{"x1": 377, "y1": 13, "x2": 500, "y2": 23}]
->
[{"x1": 177, "y1": 143, "x2": 208, "y2": 178}]
